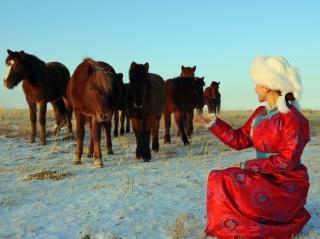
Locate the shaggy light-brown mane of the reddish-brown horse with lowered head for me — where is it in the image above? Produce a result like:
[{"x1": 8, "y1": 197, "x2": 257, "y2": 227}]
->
[{"x1": 83, "y1": 58, "x2": 112, "y2": 95}]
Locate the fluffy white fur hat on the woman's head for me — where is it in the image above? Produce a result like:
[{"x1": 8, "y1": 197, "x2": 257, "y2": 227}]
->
[{"x1": 251, "y1": 56, "x2": 302, "y2": 113}]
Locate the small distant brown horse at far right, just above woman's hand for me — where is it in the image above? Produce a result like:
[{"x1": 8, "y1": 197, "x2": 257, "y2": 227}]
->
[{"x1": 204, "y1": 81, "x2": 221, "y2": 115}]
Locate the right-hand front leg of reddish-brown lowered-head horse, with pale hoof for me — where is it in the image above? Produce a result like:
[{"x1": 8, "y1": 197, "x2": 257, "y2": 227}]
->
[{"x1": 91, "y1": 117, "x2": 103, "y2": 168}]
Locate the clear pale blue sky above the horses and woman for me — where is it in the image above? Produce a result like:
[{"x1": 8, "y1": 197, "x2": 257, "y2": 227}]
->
[{"x1": 0, "y1": 0, "x2": 320, "y2": 109}]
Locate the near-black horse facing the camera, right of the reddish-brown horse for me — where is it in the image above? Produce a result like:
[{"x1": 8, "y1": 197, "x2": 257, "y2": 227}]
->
[{"x1": 127, "y1": 62, "x2": 166, "y2": 162}]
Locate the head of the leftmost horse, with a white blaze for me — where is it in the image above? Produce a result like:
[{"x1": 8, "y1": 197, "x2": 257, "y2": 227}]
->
[{"x1": 3, "y1": 49, "x2": 31, "y2": 89}]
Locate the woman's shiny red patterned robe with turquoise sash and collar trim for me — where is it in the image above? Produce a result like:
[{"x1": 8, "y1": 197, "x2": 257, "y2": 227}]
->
[{"x1": 206, "y1": 106, "x2": 310, "y2": 239}]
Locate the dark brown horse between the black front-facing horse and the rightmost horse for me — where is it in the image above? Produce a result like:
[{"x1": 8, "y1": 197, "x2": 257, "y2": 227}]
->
[{"x1": 163, "y1": 77, "x2": 204, "y2": 145}]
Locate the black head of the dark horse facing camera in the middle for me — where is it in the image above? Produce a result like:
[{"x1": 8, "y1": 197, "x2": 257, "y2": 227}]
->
[{"x1": 129, "y1": 62, "x2": 150, "y2": 108}]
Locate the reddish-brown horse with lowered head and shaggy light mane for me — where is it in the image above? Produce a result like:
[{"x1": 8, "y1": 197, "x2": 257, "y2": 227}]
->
[{"x1": 67, "y1": 58, "x2": 112, "y2": 168}]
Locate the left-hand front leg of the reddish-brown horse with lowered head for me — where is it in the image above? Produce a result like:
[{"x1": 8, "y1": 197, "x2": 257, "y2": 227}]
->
[{"x1": 72, "y1": 111, "x2": 86, "y2": 165}]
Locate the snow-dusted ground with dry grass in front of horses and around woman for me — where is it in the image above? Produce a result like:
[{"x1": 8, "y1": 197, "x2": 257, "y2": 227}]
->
[{"x1": 0, "y1": 129, "x2": 320, "y2": 239}]
